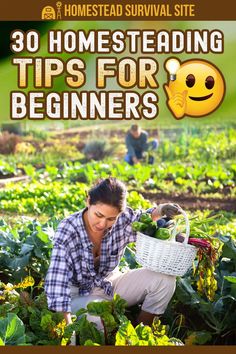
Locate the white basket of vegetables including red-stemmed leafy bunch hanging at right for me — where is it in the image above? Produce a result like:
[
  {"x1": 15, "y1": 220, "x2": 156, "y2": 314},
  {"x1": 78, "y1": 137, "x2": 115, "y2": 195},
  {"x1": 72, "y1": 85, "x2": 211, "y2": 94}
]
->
[{"x1": 132, "y1": 211, "x2": 221, "y2": 301}]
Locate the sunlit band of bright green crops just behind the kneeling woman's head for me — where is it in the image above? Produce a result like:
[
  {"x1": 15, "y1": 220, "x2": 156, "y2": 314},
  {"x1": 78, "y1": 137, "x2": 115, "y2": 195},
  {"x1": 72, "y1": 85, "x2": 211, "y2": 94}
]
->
[{"x1": 0, "y1": 159, "x2": 236, "y2": 215}]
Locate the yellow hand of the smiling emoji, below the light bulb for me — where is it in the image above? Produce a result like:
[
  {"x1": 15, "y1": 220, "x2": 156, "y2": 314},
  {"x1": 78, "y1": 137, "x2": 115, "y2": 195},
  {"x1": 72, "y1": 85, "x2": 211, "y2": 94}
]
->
[{"x1": 164, "y1": 85, "x2": 188, "y2": 119}]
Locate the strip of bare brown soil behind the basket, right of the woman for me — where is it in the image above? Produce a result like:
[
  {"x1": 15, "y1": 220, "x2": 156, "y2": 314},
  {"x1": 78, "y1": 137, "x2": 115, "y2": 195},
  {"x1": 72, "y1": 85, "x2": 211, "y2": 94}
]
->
[{"x1": 138, "y1": 192, "x2": 236, "y2": 213}]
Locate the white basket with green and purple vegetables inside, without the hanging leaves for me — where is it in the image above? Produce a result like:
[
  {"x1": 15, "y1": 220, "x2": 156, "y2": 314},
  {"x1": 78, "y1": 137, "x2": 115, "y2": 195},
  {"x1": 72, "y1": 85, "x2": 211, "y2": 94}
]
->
[{"x1": 132, "y1": 209, "x2": 197, "y2": 276}]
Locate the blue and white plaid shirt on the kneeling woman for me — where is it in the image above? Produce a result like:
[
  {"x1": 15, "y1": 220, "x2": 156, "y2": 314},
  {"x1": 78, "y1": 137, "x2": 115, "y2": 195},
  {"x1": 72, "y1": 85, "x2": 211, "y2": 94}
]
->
[{"x1": 45, "y1": 207, "x2": 142, "y2": 312}]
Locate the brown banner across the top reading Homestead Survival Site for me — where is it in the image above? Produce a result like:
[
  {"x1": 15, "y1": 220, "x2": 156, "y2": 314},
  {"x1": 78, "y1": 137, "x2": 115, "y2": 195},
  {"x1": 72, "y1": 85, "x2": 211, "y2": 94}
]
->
[{"x1": 0, "y1": 0, "x2": 236, "y2": 21}]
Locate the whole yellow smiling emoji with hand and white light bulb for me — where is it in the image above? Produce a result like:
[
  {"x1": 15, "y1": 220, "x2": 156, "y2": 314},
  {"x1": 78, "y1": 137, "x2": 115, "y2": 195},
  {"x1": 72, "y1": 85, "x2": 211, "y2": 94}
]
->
[{"x1": 164, "y1": 58, "x2": 225, "y2": 119}]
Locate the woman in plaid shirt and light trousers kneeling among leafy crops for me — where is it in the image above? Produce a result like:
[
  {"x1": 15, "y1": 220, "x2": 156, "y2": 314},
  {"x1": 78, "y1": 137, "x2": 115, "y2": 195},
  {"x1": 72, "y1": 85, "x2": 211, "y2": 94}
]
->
[{"x1": 45, "y1": 178, "x2": 179, "y2": 327}]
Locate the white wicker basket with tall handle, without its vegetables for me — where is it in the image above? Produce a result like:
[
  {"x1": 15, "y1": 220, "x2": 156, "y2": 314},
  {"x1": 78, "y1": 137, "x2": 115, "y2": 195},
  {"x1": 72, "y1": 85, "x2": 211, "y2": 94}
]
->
[{"x1": 135, "y1": 209, "x2": 197, "y2": 276}]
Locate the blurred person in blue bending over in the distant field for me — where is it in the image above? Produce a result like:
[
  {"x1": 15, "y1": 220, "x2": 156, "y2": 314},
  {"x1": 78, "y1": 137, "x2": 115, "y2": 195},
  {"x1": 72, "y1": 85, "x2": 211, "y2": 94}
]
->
[{"x1": 125, "y1": 124, "x2": 159, "y2": 165}]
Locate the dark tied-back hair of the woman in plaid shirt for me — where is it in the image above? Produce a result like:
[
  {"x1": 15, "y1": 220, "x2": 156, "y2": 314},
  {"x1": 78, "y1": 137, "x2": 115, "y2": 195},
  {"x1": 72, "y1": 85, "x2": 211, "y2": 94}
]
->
[{"x1": 88, "y1": 177, "x2": 127, "y2": 211}]
